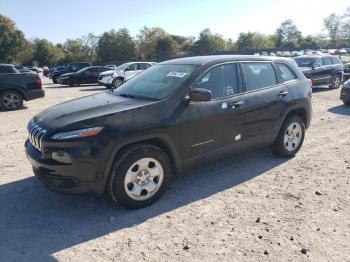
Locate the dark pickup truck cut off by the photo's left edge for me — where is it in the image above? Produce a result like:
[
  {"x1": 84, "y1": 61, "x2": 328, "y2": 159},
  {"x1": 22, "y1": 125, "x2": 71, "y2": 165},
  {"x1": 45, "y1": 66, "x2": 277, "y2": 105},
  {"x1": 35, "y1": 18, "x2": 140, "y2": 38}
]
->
[{"x1": 0, "y1": 64, "x2": 45, "y2": 110}]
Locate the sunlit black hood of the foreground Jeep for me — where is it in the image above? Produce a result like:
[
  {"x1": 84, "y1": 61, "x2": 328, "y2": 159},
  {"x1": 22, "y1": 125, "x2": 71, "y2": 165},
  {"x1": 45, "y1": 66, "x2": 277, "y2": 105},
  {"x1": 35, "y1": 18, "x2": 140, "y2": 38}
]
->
[{"x1": 34, "y1": 92, "x2": 155, "y2": 130}]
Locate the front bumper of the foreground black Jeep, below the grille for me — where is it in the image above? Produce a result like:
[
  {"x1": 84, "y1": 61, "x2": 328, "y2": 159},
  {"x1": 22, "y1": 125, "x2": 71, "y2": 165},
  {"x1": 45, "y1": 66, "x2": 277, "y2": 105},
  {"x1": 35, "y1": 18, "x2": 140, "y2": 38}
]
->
[{"x1": 25, "y1": 140, "x2": 105, "y2": 195}]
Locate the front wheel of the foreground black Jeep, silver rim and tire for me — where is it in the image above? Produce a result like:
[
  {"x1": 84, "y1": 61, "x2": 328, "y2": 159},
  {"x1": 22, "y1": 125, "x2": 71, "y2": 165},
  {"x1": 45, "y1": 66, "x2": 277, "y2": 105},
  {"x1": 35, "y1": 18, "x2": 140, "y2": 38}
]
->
[{"x1": 107, "y1": 144, "x2": 172, "y2": 209}]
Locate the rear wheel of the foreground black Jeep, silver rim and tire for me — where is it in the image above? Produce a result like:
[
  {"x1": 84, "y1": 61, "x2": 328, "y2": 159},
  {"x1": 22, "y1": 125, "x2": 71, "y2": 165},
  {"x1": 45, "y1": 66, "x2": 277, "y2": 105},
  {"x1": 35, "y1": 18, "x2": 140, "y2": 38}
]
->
[{"x1": 272, "y1": 115, "x2": 305, "y2": 157}]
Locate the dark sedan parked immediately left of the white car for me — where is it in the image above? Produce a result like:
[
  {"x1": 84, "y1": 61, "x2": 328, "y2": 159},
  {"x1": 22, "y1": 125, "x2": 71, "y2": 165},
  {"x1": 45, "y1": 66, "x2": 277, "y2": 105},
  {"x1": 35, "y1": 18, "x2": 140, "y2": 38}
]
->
[{"x1": 58, "y1": 66, "x2": 110, "y2": 86}]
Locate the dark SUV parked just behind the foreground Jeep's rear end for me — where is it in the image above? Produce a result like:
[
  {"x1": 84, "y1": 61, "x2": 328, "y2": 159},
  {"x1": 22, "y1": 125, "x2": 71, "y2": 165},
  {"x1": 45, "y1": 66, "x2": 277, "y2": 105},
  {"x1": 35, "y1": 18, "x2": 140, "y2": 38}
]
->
[{"x1": 294, "y1": 55, "x2": 344, "y2": 89}]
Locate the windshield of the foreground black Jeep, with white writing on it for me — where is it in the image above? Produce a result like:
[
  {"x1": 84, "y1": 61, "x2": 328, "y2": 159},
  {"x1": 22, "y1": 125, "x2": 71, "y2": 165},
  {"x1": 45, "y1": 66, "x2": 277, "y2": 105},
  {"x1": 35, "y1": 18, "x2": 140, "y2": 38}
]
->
[{"x1": 114, "y1": 65, "x2": 195, "y2": 100}]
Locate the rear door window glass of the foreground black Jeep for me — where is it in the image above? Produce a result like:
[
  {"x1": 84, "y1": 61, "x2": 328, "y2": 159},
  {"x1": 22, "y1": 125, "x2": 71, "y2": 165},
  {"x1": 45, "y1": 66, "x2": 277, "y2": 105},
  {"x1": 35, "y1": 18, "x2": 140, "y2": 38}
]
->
[{"x1": 242, "y1": 62, "x2": 277, "y2": 91}]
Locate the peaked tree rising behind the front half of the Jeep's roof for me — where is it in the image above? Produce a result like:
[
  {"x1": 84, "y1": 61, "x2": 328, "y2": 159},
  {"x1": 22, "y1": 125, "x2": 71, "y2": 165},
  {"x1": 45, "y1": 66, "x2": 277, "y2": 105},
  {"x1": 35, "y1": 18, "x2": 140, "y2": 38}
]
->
[{"x1": 191, "y1": 28, "x2": 225, "y2": 54}]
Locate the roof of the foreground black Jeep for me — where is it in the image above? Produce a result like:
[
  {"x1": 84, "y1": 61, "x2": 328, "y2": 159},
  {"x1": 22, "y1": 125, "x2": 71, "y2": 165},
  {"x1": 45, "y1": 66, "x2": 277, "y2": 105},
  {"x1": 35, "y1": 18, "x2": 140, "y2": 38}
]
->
[{"x1": 161, "y1": 55, "x2": 289, "y2": 65}]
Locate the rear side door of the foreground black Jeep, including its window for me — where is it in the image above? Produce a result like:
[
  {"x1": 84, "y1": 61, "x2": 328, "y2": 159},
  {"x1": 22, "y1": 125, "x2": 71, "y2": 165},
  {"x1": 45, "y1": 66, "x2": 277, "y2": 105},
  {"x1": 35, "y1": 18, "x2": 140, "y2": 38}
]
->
[{"x1": 240, "y1": 62, "x2": 291, "y2": 147}]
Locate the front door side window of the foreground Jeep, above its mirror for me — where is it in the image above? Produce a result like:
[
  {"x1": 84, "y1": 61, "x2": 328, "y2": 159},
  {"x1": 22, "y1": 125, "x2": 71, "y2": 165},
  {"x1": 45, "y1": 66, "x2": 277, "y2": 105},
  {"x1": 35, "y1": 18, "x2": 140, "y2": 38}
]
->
[{"x1": 192, "y1": 64, "x2": 239, "y2": 99}]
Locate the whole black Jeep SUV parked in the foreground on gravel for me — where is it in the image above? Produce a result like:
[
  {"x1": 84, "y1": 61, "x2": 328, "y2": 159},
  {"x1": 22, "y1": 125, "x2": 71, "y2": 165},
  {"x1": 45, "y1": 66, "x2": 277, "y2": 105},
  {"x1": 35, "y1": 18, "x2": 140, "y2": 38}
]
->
[{"x1": 25, "y1": 56, "x2": 312, "y2": 208}]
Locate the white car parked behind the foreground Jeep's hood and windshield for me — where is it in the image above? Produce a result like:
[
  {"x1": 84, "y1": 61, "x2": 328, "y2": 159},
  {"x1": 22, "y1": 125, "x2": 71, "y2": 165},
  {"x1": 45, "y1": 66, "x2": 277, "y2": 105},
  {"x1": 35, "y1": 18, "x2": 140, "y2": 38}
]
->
[{"x1": 98, "y1": 62, "x2": 156, "y2": 88}]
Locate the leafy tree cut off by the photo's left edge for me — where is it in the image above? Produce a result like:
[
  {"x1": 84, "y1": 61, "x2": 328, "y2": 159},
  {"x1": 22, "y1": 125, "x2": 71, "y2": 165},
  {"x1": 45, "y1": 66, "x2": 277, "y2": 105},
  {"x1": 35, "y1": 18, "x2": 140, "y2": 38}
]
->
[{"x1": 0, "y1": 15, "x2": 26, "y2": 63}]
